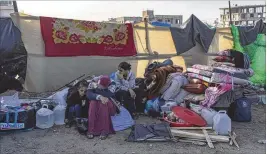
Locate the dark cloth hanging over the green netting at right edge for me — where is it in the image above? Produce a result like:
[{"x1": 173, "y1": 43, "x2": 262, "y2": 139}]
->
[{"x1": 237, "y1": 19, "x2": 266, "y2": 46}]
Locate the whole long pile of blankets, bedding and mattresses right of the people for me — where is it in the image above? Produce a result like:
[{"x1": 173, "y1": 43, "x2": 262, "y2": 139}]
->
[{"x1": 145, "y1": 50, "x2": 259, "y2": 119}]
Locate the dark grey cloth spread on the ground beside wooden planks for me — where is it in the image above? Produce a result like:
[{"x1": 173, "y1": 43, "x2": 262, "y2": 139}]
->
[{"x1": 127, "y1": 123, "x2": 172, "y2": 142}]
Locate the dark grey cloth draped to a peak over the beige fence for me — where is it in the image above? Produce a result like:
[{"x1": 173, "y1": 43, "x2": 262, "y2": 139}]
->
[{"x1": 170, "y1": 15, "x2": 216, "y2": 55}]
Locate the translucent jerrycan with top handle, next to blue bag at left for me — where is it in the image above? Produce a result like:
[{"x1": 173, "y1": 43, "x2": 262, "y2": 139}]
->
[{"x1": 36, "y1": 104, "x2": 54, "y2": 129}]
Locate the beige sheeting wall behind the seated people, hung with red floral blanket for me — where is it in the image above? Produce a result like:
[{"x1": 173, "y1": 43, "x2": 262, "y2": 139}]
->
[{"x1": 11, "y1": 14, "x2": 207, "y2": 92}]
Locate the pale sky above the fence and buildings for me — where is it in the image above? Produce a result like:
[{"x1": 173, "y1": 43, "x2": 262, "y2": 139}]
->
[{"x1": 17, "y1": 0, "x2": 265, "y2": 21}]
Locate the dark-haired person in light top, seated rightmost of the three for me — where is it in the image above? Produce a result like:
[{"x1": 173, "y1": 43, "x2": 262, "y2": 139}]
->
[{"x1": 114, "y1": 62, "x2": 141, "y2": 117}]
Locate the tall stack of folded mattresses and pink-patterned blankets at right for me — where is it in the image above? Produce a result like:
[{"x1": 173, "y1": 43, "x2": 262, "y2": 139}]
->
[{"x1": 185, "y1": 50, "x2": 255, "y2": 110}]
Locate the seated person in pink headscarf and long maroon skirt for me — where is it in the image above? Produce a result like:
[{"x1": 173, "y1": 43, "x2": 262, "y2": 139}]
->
[{"x1": 86, "y1": 76, "x2": 116, "y2": 140}]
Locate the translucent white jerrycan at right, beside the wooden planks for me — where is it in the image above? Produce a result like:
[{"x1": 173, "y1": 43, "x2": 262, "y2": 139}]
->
[{"x1": 213, "y1": 110, "x2": 231, "y2": 135}]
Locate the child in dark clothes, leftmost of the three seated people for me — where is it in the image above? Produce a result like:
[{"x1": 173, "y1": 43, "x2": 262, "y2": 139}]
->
[{"x1": 65, "y1": 80, "x2": 88, "y2": 128}]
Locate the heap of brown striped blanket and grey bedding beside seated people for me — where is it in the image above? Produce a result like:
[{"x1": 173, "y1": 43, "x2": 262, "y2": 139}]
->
[{"x1": 145, "y1": 59, "x2": 188, "y2": 117}]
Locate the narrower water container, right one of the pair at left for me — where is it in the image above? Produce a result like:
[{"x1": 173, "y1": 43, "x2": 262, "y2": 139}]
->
[{"x1": 54, "y1": 104, "x2": 66, "y2": 125}]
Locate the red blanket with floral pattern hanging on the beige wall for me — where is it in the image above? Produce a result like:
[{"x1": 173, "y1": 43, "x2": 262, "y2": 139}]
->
[{"x1": 40, "y1": 17, "x2": 136, "y2": 57}]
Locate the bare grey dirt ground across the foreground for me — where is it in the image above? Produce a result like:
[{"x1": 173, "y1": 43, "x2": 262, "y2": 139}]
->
[{"x1": 0, "y1": 104, "x2": 266, "y2": 154}]
